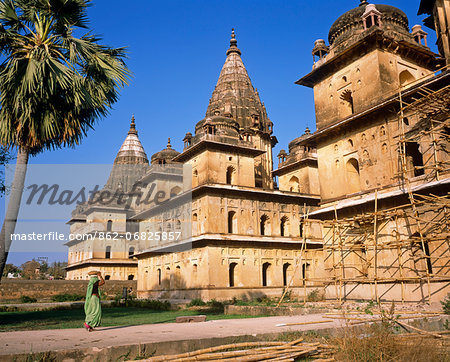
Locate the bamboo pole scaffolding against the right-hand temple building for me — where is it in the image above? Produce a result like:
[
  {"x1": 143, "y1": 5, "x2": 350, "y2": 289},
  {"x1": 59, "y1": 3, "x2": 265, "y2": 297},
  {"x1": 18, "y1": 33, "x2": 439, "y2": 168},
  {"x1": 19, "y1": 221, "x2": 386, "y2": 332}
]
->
[{"x1": 284, "y1": 67, "x2": 450, "y2": 303}]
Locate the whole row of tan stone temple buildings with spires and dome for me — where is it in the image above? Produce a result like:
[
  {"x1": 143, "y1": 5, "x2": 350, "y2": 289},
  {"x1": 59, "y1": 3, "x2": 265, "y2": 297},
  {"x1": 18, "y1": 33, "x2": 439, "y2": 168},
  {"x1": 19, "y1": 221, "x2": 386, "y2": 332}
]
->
[{"x1": 67, "y1": 0, "x2": 450, "y2": 301}]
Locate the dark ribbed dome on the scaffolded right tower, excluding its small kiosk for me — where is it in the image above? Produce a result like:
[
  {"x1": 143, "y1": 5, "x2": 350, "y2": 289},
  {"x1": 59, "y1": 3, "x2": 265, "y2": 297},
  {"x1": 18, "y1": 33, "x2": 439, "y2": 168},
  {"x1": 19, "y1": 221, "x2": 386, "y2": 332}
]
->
[{"x1": 328, "y1": 0, "x2": 409, "y2": 45}]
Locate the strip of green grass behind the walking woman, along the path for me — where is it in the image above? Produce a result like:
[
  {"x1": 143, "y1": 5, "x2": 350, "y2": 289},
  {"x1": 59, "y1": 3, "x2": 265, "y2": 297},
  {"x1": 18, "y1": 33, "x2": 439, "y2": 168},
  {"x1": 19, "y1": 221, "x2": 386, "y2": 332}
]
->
[{"x1": 0, "y1": 307, "x2": 260, "y2": 332}]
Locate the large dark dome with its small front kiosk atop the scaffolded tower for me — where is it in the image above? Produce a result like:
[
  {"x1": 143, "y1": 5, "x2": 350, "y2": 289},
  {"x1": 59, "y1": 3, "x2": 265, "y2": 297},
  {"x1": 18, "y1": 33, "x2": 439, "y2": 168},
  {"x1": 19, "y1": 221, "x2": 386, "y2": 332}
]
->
[{"x1": 328, "y1": 0, "x2": 409, "y2": 46}]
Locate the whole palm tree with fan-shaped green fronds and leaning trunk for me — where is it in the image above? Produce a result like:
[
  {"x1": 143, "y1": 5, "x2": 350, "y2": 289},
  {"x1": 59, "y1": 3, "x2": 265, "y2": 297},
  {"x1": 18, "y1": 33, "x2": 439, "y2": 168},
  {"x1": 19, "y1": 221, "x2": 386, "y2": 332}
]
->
[{"x1": 0, "y1": 0, "x2": 130, "y2": 275}]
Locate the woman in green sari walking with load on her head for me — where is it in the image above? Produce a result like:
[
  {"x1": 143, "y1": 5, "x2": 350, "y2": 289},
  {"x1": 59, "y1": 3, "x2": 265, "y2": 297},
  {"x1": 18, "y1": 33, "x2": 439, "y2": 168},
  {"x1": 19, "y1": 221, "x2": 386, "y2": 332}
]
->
[{"x1": 84, "y1": 271, "x2": 105, "y2": 332}]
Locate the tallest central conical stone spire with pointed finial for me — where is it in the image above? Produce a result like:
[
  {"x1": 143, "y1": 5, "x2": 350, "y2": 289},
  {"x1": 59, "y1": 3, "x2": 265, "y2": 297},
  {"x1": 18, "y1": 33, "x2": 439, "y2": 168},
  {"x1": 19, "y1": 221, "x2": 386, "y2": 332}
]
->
[{"x1": 202, "y1": 29, "x2": 270, "y2": 130}]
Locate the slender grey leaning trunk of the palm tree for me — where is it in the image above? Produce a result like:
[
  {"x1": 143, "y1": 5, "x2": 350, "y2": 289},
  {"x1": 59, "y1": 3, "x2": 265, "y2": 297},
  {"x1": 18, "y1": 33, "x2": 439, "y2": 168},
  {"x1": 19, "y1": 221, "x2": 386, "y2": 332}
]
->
[{"x1": 0, "y1": 149, "x2": 29, "y2": 280}]
